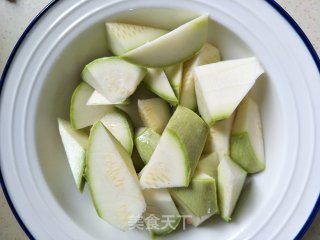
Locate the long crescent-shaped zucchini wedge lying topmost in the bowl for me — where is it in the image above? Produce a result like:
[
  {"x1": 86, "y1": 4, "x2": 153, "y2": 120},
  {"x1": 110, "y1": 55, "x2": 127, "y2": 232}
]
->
[{"x1": 123, "y1": 15, "x2": 208, "y2": 68}]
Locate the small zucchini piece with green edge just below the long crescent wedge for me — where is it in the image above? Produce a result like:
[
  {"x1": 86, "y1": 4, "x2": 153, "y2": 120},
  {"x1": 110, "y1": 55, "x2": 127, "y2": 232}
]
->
[{"x1": 143, "y1": 68, "x2": 178, "y2": 106}]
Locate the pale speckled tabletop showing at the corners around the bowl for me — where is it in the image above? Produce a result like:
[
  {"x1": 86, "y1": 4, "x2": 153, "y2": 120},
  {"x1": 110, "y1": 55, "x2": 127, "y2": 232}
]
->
[{"x1": 0, "y1": 0, "x2": 320, "y2": 240}]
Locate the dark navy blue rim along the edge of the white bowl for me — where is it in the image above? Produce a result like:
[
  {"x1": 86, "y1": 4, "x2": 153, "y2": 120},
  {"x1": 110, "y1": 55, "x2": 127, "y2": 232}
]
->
[{"x1": 0, "y1": 0, "x2": 320, "y2": 240}]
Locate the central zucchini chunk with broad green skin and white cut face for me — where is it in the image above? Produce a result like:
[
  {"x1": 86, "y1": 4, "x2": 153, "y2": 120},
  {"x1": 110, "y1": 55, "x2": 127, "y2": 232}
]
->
[{"x1": 140, "y1": 106, "x2": 208, "y2": 188}]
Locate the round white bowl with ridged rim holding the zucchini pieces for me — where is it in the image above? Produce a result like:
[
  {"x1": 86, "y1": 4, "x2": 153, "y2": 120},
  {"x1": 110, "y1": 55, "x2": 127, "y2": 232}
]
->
[{"x1": 0, "y1": 0, "x2": 320, "y2": 240}]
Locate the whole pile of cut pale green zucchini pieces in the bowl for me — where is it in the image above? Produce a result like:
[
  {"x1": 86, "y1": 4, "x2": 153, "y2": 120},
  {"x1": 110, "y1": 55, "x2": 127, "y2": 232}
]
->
[{"x1": 58, "y1": 15, "x2": 265, "y2": 236}]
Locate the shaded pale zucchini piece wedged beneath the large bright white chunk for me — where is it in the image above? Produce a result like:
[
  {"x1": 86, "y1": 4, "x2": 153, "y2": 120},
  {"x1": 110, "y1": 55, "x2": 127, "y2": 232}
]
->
[{"x1": 203, "y1": 113, "x2": 235, "y2": 158}]
